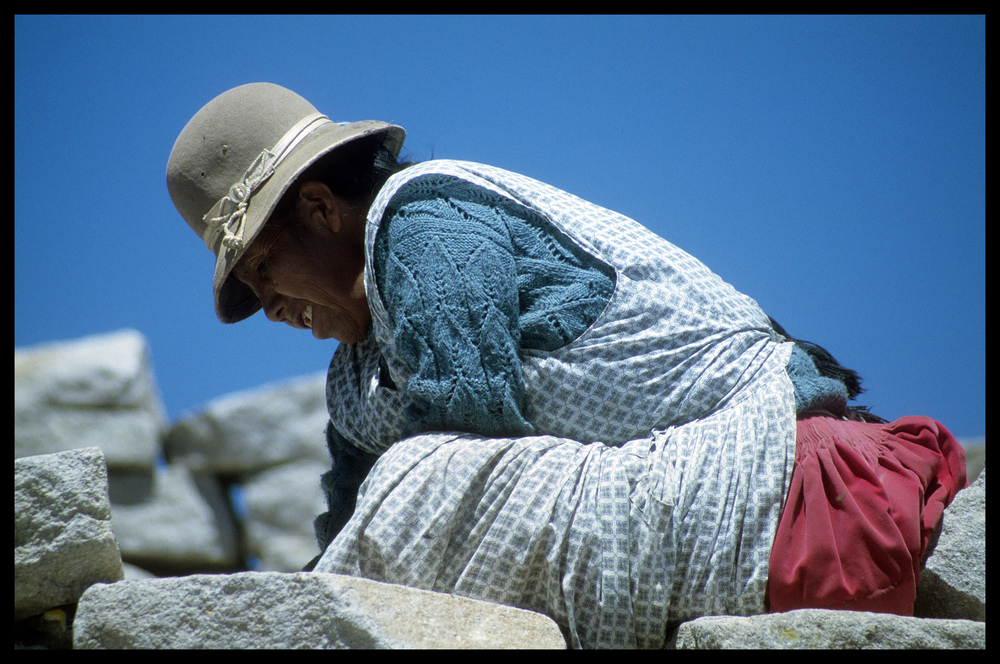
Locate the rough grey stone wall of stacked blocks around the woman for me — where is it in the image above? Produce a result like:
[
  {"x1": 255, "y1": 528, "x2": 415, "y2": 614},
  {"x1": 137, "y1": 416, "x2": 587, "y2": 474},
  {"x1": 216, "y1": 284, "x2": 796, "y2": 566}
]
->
[{"x1": 14, "y1": 330, "x2": 986, "y2": 649}]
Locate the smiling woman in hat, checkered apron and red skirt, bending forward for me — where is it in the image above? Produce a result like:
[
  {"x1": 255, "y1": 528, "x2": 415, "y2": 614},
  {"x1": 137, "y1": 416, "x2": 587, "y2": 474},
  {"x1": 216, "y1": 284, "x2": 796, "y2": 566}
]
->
[{"x1": 167, "y1": 84, "x2": 967, "y2": 647}]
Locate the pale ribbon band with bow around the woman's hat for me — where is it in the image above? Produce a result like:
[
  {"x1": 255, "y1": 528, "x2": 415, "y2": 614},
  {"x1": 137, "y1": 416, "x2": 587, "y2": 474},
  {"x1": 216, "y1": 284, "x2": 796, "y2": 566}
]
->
[{"x1": 201, "y1": 113, "x2": 330, "y2": 251}]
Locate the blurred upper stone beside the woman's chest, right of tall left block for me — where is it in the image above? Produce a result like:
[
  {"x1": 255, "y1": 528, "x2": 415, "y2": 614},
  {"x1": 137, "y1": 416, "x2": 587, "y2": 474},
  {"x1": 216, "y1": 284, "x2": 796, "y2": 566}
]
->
[{"x1": 164, "y1": 374, "x2": 329, "y2": 475}]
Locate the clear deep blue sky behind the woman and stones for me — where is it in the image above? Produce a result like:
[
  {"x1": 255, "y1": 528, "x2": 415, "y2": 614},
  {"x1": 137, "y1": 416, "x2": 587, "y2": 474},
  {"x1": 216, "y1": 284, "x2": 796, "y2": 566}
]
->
[{"x1": 14, "y1": 16, "x2": 986, "y2": 437}]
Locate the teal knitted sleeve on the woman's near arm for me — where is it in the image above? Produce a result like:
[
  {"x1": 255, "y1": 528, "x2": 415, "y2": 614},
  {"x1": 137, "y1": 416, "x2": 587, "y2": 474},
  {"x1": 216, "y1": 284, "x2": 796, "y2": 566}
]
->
[{"x1": 375, "y1": 189, "x2": 534, "y2": 436}]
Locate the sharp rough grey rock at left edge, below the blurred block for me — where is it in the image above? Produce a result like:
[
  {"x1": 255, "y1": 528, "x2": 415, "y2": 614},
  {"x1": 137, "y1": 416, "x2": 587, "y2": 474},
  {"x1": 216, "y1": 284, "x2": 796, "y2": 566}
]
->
[{"x1": 14, "y1": 447, "x2": 122, "y2": 621}]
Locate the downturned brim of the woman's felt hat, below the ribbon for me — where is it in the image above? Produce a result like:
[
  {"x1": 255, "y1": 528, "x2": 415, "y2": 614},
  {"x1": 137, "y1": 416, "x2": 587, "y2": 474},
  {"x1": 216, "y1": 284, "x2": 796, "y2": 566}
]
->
[{"x1": 212, "y1": 120, "x2": 406, "y2": 323}]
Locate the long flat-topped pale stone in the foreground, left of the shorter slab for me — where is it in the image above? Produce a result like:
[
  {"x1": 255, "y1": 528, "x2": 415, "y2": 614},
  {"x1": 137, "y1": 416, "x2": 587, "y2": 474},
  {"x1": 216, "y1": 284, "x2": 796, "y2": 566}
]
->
[{"x1": 73, "y1": 572, "x2": 564, "y2": 648}]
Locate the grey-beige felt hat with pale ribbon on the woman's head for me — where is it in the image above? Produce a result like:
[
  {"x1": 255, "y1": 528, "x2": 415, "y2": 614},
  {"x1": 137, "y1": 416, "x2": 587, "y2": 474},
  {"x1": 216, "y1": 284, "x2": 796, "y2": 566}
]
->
[{"x1": 167, "y1": 83, "x2": 406, "y2": 323}]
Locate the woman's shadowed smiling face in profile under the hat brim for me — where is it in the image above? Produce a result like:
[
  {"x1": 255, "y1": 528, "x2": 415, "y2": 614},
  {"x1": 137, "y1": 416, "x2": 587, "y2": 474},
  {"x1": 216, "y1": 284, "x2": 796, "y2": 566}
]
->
[{"x1": 233, "y1": 187, "x2": 371, "y2": 343}]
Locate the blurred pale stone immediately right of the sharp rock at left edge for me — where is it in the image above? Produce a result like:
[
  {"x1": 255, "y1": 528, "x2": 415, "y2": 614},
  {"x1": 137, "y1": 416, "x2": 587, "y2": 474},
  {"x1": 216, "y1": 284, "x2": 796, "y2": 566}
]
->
[{"x1": 112, "y1": 466, "x2": 240, "y2": 570}]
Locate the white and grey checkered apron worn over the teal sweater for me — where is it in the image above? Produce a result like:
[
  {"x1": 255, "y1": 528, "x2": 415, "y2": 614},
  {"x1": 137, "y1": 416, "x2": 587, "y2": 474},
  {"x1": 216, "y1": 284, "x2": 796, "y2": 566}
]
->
[{"x1": 316, "y1": 161, "x2": 795, "y2": 647}]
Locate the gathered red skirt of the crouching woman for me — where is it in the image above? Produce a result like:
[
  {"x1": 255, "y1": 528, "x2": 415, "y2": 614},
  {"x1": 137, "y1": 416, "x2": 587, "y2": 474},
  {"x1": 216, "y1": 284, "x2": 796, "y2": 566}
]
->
[{"x1": 767, "y1": 414, "x2": 969, "y2": 615}]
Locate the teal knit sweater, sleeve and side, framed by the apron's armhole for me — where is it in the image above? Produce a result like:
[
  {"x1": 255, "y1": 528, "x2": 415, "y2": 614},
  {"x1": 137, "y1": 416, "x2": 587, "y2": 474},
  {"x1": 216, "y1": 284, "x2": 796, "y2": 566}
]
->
[{"x1": 375, "y1": 180, "x2": 614, "y2": 436}]
